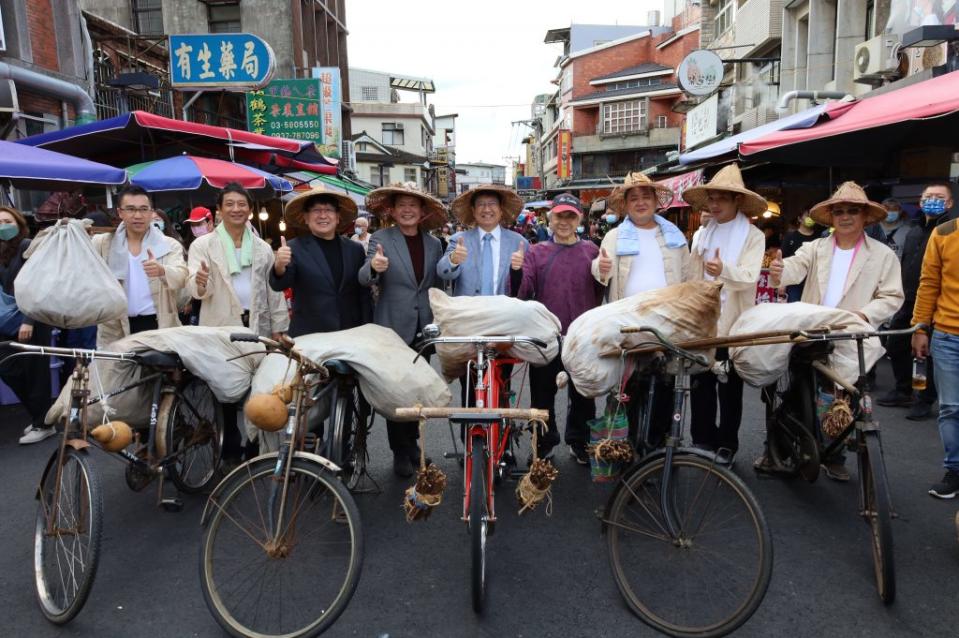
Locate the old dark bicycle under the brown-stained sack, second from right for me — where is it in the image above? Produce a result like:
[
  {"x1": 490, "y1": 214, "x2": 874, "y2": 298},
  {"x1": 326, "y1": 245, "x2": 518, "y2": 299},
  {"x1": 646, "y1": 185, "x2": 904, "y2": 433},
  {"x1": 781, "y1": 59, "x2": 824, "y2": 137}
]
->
[{"x1": 600, "y1": 327, "x2": 773, "y2": 638}]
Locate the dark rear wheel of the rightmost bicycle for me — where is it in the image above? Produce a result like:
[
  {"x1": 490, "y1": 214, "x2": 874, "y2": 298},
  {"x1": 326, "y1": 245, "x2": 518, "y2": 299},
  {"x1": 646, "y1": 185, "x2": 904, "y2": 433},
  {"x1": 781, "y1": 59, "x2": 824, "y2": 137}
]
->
[{"x1": 763, "y1": 369, "x2": 819, "y2": 483}]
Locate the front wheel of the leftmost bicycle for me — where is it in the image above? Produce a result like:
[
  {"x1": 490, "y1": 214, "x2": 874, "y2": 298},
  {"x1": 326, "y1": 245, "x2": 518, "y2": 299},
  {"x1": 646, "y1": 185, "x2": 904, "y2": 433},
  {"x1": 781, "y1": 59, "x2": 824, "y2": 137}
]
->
[{"x1": 33, "y1": 446, "x2": 103, "y2": 625}]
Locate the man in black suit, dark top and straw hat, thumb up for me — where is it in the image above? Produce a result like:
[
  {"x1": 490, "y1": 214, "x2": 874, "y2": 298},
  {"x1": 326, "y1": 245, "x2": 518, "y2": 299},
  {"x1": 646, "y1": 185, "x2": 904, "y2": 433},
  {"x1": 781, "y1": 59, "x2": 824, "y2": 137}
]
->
[{"x1": 270, "y1": 186, "x2": 372, "y2": 337}]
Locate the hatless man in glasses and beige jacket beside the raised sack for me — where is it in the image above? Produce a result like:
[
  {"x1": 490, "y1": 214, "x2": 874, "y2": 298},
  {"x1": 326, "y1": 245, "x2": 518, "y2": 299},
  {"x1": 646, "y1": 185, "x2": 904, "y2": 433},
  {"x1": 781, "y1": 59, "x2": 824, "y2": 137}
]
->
[{"x1": 93, "y1": 186, "x2": 187, "y2": 347}]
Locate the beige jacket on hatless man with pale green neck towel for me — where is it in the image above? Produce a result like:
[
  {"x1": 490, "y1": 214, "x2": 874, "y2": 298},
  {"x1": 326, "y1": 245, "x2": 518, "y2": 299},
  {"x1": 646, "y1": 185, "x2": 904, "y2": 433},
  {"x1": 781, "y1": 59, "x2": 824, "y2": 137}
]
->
[{"x1": 187, "y1": 232, "x2": 290, "y2": 337}]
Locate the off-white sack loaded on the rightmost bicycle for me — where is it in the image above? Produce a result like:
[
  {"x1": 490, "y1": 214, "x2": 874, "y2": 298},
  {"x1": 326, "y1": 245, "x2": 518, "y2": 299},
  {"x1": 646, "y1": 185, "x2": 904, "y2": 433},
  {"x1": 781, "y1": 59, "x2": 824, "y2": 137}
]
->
[{"x1": 729, "y1": 302, "x2": 885, "y2": 388}]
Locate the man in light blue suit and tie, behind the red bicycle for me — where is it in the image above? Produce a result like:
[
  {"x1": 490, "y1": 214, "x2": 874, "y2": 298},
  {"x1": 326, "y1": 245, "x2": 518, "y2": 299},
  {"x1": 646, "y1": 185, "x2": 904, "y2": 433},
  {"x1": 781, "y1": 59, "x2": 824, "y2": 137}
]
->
[{"x1": 436, "y1": 184, "x2": 529, "y2": 405}]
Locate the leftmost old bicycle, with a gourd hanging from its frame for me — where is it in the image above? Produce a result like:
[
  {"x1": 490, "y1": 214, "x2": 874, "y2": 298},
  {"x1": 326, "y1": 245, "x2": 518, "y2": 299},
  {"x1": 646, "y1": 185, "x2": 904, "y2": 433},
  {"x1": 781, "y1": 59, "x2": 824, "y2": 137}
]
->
[{"x1": 8, "y1": 343, "x2": 223, "y2": 625}]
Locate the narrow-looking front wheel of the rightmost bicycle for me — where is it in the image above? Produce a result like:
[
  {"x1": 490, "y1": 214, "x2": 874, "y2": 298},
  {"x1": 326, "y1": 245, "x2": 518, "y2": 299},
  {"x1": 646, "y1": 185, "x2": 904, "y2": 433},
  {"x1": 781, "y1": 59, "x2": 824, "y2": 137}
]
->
[{"x1": 859, "y1": 432, "x2": 896, "y2": 605}]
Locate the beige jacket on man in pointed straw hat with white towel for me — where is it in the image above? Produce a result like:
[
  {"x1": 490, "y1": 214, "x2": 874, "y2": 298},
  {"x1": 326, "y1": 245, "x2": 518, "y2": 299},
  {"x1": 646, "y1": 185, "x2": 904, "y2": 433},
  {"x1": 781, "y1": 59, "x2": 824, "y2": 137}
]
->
[{"x1": 689, "y1": 225, "x2": 766, "y2": 336}]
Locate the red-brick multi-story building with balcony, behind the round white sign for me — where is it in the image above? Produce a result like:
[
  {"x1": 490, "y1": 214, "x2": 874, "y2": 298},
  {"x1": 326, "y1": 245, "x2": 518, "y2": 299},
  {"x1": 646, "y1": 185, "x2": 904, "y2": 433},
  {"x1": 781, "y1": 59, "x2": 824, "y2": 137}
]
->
[{"x1": 526, "y1": 12, "x2": 699, "y2": 201}]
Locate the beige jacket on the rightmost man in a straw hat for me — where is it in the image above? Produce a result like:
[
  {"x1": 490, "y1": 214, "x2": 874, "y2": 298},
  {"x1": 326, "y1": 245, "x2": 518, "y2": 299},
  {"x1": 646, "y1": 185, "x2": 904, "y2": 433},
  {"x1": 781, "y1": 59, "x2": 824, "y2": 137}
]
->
[{"x1": 771, "y1": 236, "x2": 905, "y2": 328}]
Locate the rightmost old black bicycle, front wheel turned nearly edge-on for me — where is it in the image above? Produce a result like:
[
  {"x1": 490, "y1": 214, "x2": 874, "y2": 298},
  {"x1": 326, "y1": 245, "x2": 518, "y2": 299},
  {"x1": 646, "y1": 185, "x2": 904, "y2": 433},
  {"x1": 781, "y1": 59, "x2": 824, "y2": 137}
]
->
[{"x1": 757, "y1": 326, "x2": 921, "y2": 605}]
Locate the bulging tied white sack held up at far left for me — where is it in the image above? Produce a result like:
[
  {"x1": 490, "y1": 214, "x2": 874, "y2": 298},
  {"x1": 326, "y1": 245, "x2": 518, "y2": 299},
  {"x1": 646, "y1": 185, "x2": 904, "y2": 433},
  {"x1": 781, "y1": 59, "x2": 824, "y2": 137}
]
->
[{"x1": 14, "y1": 219, "x2": 127, "y2": 328}]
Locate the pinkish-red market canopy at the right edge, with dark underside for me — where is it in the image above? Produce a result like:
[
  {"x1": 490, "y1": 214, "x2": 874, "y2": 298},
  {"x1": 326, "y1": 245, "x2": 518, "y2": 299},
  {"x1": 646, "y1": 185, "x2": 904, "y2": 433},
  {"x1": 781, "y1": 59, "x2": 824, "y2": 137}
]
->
[{"x1": 739, "y1": 73, "x2": 959, "y2": 166}]
